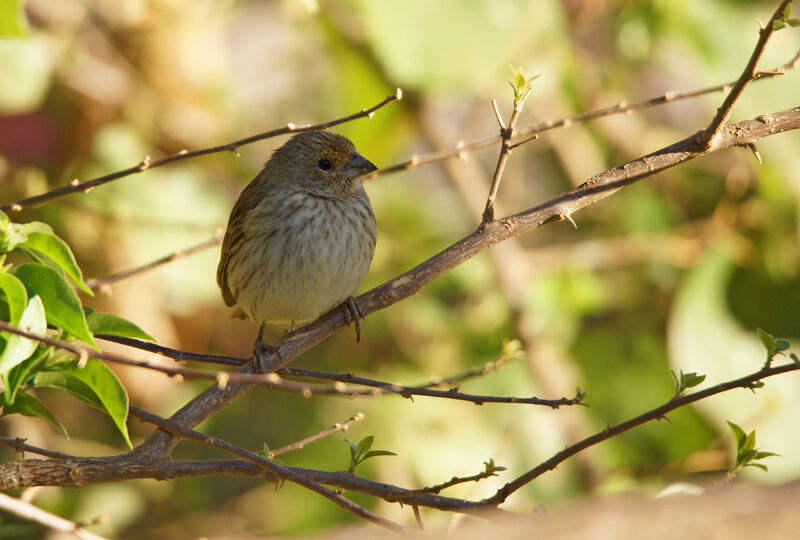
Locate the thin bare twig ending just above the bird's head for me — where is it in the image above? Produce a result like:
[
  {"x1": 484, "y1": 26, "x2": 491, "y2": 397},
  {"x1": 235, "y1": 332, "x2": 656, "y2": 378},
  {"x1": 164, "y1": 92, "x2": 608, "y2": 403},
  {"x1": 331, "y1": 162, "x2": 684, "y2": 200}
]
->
[{"x1": 0, "y1": 88, "x2": 403, "y2": 212}]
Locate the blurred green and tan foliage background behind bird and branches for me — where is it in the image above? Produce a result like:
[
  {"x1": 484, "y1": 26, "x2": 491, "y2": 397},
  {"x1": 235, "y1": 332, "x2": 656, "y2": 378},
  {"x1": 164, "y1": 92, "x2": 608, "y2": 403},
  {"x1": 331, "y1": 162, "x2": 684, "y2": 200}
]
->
[{"x1": 0, "y1": 0, "x2": 800, "y2": 538}]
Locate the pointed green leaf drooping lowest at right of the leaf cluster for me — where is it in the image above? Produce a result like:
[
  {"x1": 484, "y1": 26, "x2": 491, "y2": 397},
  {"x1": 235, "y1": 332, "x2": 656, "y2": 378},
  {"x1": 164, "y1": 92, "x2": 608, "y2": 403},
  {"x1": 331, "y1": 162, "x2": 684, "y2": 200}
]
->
[{"x1": 34, "y1": 358, "x2": 133, "y2": 448}]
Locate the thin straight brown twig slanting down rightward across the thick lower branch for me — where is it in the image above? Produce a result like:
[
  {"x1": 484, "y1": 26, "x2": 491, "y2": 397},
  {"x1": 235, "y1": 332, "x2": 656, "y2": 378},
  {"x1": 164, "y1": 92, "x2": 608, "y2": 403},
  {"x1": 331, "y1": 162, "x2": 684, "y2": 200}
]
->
[{"x1": 130, "y1": 405, "x2": 406, "y2": 532}]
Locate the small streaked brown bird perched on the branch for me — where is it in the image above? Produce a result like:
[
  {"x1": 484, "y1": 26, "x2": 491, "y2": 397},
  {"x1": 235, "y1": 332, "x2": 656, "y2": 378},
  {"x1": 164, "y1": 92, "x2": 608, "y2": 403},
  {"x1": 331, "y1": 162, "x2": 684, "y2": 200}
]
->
[{"x1": 217, "y1": 131, "x2": 377, "y2": 367}]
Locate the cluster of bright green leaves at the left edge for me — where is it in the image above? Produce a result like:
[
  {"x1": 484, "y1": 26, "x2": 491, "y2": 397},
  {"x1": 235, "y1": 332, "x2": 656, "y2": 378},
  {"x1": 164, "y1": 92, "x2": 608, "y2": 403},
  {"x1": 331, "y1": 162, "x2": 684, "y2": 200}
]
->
[{"x1": 0, "y1": 212, "x2": 153, "y2": 447}]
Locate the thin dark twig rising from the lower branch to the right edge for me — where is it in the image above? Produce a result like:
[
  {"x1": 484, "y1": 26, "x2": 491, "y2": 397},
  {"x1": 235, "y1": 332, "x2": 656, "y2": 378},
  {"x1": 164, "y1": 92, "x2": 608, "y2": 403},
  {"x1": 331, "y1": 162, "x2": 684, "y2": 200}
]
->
[{"x1": 482, "y1": 363, "x2": 800, "y2": 506}]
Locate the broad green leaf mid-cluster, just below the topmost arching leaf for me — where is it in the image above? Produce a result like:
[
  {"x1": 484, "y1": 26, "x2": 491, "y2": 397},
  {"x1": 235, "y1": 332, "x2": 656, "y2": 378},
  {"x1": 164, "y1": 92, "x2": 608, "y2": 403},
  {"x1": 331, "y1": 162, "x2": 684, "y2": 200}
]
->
[{"x1": 12, "y1": 263, "x2": 99, "y2": 350}]
